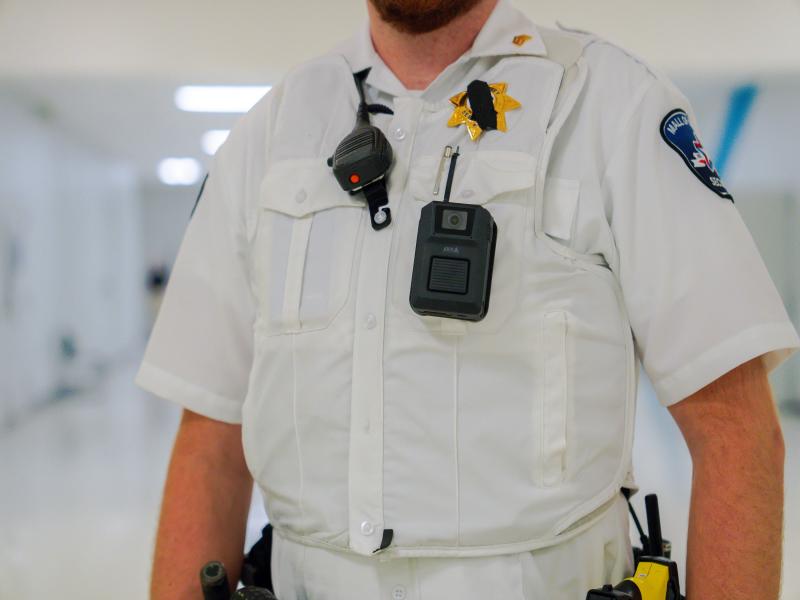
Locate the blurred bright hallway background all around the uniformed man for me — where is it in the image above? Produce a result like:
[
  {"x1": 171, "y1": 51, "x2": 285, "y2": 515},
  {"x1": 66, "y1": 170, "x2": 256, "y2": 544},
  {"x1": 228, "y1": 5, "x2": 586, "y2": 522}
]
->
[{"x1": 0, "y1": 0, "x2": 800, "y2": 600}]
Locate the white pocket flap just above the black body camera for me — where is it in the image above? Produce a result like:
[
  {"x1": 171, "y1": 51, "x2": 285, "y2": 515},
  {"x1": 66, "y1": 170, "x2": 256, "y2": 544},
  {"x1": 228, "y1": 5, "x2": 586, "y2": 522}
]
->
[{"x1": 411, "y1": 150, "x2": 536, "y2": 204}]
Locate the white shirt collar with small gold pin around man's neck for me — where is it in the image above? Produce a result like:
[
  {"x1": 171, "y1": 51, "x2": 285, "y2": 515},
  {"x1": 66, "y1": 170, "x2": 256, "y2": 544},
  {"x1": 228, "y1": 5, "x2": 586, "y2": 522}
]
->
[{"x1": 334, "y1": 0, "x2": 547, "y2": 95}]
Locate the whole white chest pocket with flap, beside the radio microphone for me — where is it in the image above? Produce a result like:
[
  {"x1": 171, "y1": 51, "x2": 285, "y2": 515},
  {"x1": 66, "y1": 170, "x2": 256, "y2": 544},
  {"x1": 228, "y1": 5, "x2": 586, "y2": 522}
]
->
[{"x1": 252, "y1": 158, "x2": 366, "y2": 335}]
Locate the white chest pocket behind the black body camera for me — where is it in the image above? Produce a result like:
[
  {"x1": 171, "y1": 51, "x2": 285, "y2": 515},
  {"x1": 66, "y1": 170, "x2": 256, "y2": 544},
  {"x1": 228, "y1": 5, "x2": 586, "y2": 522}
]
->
[{"x1": 392, "y1": 150, "x2": 536, "y2": 334}]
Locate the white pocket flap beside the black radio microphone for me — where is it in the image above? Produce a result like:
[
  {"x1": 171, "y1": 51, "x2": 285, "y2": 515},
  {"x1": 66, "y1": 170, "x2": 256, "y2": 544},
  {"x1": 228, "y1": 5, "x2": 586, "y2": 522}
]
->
[{"x1": 260, "y1": 158, "x2": 366, "y2": 217}]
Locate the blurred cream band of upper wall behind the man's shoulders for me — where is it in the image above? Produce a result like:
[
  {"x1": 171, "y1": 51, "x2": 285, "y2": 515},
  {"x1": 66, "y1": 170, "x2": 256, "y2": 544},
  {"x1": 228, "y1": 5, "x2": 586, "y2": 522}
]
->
[{"x1": 0, "y1": 0, "x2": 800, "y2": 81}]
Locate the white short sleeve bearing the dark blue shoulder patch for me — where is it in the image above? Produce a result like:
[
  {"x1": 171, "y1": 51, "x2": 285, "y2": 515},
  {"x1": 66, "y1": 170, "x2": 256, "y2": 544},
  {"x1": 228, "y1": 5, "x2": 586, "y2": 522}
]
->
[{"x1": 545, "y1": 42, "x2": 798, "y2": 406}]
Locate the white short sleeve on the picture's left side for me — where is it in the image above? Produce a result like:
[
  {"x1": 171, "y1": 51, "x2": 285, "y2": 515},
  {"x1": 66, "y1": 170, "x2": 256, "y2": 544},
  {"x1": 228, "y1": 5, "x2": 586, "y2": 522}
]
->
[{"x1": 136, "y1": 105, "x2": 269, "y2": 423}]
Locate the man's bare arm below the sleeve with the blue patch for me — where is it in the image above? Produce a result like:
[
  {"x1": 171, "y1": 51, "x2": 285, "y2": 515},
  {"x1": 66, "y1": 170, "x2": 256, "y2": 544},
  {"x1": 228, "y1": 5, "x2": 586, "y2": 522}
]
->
[{"x1": 669, "y1": 358, "x2": 784, "y2": 600}]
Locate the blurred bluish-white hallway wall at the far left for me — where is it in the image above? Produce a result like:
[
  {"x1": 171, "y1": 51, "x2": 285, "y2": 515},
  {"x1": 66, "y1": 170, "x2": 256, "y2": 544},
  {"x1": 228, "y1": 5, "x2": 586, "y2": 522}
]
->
[{"x1": 0, "y1": 94, "x2": 144, "y2": 426}]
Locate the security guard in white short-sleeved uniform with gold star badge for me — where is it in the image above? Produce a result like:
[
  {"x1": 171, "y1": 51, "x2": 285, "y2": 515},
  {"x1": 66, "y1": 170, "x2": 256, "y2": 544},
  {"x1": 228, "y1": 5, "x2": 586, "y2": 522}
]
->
[{"x1": 138, "y1": 0, "x2": 798, "y2": 600}]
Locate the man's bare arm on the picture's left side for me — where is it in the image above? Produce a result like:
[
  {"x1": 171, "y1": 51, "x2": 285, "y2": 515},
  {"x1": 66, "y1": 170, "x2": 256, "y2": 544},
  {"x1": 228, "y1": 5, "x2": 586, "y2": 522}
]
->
[{"x1": 150, "y1": 410, "x2": 253, "y2": 600}]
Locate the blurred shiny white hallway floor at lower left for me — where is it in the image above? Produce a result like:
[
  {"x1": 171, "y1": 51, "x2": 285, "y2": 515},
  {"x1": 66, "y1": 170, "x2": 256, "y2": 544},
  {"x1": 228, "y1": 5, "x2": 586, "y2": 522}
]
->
[{"x1": 0, "y1": 361, "x2": 266, "y2": 600}]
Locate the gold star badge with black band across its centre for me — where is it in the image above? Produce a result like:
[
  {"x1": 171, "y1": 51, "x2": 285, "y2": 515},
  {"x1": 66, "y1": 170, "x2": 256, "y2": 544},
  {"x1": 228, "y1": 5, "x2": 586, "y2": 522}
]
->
[{"x1": 447, "y1": 79, "x2": 522, "y2": 142}]
